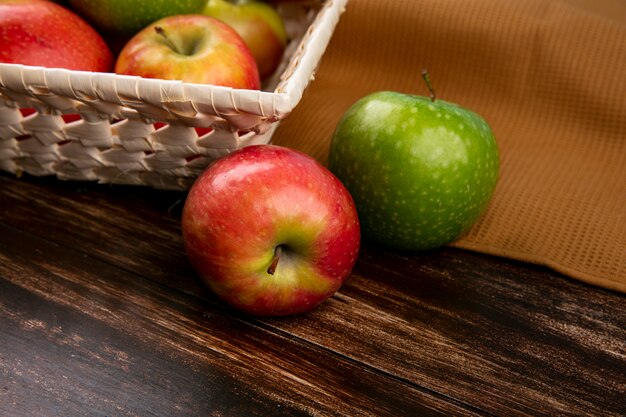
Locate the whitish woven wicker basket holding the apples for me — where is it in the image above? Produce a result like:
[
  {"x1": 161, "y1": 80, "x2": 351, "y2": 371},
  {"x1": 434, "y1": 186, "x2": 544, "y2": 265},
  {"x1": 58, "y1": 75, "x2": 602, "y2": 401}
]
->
[{"x1": 0, "y1": 0, "x2": 347, "y2": 190}]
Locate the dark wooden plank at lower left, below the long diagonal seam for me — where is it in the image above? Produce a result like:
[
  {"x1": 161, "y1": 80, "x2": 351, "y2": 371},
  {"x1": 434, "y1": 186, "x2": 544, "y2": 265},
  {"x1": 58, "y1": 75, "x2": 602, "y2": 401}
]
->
[{"x1": 0, "y1": 226, "x2": 471, "y2": 416}]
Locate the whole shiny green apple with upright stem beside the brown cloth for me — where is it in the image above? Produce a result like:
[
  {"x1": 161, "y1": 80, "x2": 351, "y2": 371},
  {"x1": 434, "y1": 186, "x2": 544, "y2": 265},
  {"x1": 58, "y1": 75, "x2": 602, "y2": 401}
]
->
[{"x1": 329, "y1": 72, "x2": 500, "y2": 250}]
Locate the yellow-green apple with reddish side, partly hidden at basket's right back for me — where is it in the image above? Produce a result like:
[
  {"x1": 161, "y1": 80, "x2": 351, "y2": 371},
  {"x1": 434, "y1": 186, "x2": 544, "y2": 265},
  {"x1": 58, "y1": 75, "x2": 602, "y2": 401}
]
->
[{"x1": 203, "y1": 0, "x2": 287, "y2": 79}]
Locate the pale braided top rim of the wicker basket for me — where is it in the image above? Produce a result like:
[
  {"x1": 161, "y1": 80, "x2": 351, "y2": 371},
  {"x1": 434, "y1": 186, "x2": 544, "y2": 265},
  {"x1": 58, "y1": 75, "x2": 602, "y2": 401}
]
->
[{"x1": 0, "y1": 0, "x2": 348, "y2": 128}]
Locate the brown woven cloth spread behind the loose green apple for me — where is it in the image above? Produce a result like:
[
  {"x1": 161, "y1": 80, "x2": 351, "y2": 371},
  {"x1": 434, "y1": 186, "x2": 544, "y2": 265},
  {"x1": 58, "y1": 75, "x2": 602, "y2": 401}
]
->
[{"x1": 274, "y1": 0, "x2": 626, "y2": 292}]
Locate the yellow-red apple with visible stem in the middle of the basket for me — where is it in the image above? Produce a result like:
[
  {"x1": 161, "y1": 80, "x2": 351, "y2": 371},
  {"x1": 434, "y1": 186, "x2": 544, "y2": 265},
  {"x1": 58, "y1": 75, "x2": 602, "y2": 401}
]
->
[{"x1": 115, "y1": 15, "x2": 261, "y2": 90}]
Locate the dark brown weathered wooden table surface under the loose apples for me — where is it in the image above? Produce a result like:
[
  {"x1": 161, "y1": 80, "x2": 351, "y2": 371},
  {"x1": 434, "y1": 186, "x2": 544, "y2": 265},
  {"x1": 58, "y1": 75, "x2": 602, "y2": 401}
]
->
[{"x1": 0, "y1": 174, "x2": 626, "y2": 417}]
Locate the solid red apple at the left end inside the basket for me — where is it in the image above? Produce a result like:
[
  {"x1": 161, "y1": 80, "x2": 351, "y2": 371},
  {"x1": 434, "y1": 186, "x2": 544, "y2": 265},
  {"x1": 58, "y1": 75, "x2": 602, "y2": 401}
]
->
[{"x1": 0, "y1": 0, "x2": 113, "y2": 72}]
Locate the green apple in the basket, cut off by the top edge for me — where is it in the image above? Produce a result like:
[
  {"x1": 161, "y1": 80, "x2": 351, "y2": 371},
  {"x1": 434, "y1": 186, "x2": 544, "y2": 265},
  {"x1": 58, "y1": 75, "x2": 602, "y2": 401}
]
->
[{"x1": 69, "y1": 0, "x2": 206, "y2": 36}]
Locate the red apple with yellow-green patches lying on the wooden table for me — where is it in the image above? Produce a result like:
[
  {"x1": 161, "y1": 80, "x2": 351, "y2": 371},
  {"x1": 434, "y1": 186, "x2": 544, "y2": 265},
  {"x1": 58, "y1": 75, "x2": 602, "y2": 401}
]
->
[{"x1": 182, "y1": 145, "x2": 360, "y2": 316}]
